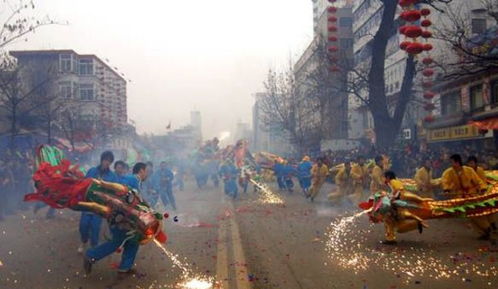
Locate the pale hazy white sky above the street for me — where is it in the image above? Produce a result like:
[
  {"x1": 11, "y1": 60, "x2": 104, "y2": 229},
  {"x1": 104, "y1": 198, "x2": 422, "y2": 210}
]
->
[{"x1": 10, "y1": 0, "x2": 312, "y2": 137}]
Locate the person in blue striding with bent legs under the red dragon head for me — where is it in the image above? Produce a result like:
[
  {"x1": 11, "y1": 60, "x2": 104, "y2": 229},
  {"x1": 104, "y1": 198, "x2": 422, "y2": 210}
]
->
[{"x1": 83, "y1": 163, "x2": 148, "y2": 276}]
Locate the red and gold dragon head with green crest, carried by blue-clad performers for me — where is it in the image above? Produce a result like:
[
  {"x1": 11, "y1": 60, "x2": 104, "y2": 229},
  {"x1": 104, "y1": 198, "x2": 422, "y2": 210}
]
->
[{"x1": 24, "y1": 145, "x2": 167, "y2": 244}]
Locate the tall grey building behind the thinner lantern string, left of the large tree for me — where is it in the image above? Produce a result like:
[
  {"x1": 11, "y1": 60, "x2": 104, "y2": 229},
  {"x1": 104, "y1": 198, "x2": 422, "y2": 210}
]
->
[{"x1": 294, "y1": 1, "x2": 353, "y2": 151}]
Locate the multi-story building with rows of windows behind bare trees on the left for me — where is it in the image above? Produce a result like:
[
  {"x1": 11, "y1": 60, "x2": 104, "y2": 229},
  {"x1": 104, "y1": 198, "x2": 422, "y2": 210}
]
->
[{"x1": 10, "y1": 50, "x2": 127, "y2": 134}]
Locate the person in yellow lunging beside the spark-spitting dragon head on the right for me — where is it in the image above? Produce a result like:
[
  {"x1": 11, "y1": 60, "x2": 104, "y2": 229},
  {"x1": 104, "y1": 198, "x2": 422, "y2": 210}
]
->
[{"x1": 383, "y1": 171, "x2": 432, "y2": 245}]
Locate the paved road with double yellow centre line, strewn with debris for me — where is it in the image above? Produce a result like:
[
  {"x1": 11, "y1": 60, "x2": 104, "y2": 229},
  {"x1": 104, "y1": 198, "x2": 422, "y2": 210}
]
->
[{"x1": 0, "y1": 181, "x2": 498, "y2": 289}]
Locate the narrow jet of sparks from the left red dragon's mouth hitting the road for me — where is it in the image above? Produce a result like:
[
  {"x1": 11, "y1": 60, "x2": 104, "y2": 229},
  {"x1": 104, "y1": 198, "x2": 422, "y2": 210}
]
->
[{"x1": 154, "y1": 240, "x2": 214, "y2": 289}]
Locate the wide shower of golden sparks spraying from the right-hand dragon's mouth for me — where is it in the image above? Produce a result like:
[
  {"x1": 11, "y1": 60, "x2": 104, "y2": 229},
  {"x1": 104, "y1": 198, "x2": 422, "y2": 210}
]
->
[{"x1": 325, "y1": 211, "x2": 498, "y2": 282}]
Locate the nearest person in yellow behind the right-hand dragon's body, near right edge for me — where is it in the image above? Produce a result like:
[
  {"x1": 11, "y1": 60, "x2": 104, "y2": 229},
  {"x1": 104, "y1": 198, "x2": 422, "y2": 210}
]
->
[{"x1": 441, "y1": 154, "x2": 491, "y2": 240}]
